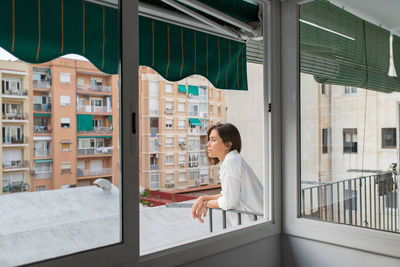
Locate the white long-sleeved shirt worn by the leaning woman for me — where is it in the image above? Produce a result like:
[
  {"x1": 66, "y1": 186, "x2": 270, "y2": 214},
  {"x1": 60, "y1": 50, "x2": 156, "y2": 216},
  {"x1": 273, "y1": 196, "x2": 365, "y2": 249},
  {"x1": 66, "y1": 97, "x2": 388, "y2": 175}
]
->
[{"x1": 218, "y1": 150, "x2": 263, "y2": 226}]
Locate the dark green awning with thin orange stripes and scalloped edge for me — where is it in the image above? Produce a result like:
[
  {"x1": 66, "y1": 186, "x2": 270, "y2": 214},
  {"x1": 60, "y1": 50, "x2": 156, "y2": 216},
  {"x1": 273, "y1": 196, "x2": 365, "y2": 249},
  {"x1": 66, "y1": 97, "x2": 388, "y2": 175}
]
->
[{"x1": 0, "y1": 0, "x2": 247, "y2": 90}]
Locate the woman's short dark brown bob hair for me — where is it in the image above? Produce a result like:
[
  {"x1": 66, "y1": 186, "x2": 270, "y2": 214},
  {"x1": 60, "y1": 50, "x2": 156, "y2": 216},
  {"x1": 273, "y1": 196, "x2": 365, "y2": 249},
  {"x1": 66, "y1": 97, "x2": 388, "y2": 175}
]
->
[{"x1": 206, "y1": 123, "x2": 242, "y2": 165}]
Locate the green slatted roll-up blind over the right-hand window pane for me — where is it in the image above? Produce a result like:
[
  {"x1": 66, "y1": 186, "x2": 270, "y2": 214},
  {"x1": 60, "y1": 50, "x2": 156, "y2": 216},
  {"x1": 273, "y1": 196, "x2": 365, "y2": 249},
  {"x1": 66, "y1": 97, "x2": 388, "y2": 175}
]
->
[{"x1": 300, "y1": 0, "x2": 400, "y2": 92}]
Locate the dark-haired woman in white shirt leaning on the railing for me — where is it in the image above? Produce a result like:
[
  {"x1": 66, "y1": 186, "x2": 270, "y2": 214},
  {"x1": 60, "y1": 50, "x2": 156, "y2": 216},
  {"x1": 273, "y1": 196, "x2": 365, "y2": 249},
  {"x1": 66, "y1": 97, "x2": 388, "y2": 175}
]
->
[{"x1": 192, "y1": 123, "x2": 263, "y2": 226}]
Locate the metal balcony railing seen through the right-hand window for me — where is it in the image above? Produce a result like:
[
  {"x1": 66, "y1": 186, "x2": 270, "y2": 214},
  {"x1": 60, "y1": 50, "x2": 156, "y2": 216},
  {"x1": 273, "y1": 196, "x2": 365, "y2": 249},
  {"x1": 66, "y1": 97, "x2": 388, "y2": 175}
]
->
[{"x1": 301, "y1": 172, "x2": 399, "y2": 232}]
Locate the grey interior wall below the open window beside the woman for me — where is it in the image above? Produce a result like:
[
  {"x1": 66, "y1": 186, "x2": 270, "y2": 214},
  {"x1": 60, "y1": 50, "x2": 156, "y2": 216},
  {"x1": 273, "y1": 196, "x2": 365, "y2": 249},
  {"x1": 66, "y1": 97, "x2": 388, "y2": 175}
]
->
[{"x1": 183, "y1": 235, "x2": 282, "y2": 267}]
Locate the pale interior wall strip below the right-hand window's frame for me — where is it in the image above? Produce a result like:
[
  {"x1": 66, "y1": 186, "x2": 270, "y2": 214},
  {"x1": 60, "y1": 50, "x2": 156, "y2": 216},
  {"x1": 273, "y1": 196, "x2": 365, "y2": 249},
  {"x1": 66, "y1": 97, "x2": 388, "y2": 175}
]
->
[{"x1": 281, "y1": 235, "x2": 400, "y2": 267}]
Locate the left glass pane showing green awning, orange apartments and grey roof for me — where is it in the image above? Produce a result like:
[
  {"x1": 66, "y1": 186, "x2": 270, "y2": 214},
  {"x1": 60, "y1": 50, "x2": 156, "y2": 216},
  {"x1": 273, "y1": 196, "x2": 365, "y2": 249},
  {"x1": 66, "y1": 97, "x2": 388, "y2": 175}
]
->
[{"x1": 0, "y1": 1, "x2": 121, "y2": 266}]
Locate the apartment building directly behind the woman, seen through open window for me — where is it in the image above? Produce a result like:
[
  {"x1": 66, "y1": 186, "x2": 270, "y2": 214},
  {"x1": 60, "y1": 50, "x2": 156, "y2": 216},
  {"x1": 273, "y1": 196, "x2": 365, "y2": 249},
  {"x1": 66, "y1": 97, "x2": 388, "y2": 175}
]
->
[{"x1": 139, "y1": 67, "x2": 226, "y2": 190}]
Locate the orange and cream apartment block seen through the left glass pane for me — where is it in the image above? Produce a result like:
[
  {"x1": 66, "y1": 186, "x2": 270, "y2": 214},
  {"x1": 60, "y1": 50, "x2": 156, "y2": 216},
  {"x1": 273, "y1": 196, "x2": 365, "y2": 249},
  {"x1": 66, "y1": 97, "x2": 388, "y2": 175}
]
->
[{"x1": 0, "y1": 58, "x2": 119, "y2": 193}]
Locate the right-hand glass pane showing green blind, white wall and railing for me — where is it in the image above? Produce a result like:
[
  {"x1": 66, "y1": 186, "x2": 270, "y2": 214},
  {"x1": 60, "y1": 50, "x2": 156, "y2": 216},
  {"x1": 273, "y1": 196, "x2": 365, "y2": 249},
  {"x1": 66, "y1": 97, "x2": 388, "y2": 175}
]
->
[{"x1": 299, "y1": 0, "x2": 400, "y2": 232}]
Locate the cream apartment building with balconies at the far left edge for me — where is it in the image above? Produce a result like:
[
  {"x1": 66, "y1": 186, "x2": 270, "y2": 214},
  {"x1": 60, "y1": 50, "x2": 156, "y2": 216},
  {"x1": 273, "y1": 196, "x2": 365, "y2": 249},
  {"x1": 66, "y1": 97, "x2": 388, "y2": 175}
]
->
[{"x1": 0, "y1": 60, "x2": 31, "y2": 194}]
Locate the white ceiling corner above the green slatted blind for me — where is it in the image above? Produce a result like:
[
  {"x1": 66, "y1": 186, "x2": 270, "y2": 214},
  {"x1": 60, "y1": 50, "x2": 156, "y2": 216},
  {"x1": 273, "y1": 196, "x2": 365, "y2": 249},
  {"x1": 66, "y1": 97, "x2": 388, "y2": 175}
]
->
[{"x1": 330, "y1": 0, "x2": 400, "y2": 36}]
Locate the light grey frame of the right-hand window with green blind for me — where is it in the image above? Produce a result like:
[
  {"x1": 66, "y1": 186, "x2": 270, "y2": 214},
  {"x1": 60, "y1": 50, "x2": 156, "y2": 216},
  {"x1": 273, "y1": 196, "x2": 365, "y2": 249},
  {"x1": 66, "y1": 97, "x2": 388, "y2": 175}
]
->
[{"x1": 282, "y1": 0, "x2": 400, "y2": 258}]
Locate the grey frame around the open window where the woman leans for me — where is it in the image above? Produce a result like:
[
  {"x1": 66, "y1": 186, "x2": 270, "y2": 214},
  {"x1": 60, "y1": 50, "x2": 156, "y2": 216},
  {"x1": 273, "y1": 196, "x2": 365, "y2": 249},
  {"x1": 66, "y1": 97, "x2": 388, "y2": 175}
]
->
[{"x1": 41, "y1": 0, "x2": 278, "y2": 266}]
